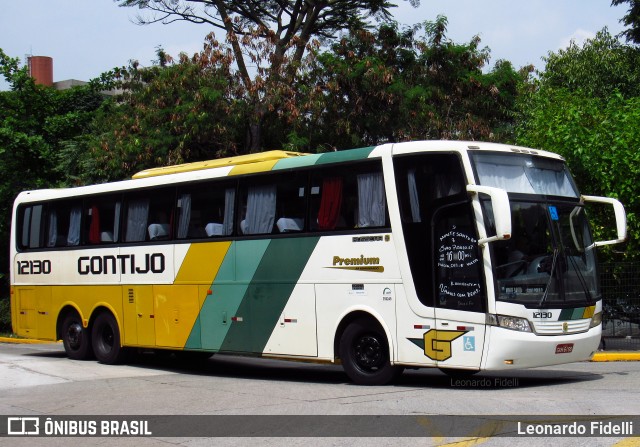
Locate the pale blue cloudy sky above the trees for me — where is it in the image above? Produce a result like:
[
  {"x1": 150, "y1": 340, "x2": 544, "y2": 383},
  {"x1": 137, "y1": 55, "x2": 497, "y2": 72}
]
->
[{"x1": 0, "y1": 0, "x2": 628, "y2": 90}]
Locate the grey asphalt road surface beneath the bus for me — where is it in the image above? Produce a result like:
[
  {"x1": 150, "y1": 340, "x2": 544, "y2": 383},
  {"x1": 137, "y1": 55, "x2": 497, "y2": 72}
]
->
[{"x1": 0, "y1": 343, "x2": 640, "y2": 447}]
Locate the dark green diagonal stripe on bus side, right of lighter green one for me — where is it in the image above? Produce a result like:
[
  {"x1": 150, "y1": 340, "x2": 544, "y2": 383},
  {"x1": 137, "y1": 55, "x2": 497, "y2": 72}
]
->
[{"x1": 220, "y1": 237, "x2": 319, "y2": 353}]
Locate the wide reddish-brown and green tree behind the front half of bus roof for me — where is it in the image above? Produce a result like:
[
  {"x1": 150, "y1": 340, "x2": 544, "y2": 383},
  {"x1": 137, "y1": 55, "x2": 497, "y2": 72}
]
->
[{"x1": 296, "y1": 16, "x2": 528, "y2": 147}]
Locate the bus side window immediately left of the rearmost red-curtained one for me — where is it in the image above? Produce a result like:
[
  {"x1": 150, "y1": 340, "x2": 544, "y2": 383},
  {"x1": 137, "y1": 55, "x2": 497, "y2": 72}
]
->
[{"x1": 45, "y1": 199, "x2": 82, "y2": 248}]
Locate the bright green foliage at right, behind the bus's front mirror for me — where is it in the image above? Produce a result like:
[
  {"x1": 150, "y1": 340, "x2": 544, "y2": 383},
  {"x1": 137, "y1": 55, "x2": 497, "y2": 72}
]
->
[{"x1": 517, "y1": 31, "x2": 640, "y2": 259}]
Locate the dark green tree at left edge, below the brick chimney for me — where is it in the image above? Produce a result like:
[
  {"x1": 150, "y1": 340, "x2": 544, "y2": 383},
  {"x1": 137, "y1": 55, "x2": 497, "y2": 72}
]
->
[{"x1": 0, "y1": 49, "x2": 103, "y2": 294}]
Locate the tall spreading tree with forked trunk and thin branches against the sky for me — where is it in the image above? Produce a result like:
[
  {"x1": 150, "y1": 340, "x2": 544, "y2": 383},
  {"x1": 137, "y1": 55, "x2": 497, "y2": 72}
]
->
[{"x1": 115, "y1": 0, "x2": 419, "y2": 151}]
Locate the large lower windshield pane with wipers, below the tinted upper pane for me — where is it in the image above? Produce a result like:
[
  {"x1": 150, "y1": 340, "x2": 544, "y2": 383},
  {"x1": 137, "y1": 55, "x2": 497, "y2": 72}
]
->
[{"x1": 492, "y1": 201, "x2": 599, "y2": 308}]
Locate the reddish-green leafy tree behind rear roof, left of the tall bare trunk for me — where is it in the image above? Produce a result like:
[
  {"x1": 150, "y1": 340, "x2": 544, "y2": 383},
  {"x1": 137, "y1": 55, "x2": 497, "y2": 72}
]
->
[{"x1": 82, "y1": 42, "x2": 246, "y2": 182}]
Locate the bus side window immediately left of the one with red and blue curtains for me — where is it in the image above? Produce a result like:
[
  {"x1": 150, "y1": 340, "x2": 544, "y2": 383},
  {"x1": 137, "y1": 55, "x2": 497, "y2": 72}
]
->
[{"x1": 238, "y1": 173, "x2": 307, "y2": 235}]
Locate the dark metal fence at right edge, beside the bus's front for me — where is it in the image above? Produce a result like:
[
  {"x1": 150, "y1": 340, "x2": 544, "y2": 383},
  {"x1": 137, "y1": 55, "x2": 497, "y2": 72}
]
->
[{"x1": 600, "y1": 262, "x2": 640, "y2": 351}]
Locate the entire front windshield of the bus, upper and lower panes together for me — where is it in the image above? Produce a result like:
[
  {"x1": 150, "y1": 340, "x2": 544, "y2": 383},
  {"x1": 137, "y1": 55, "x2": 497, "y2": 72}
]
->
[{"x1": 474, "y1": 154, "x2": 599, "y2": 308}]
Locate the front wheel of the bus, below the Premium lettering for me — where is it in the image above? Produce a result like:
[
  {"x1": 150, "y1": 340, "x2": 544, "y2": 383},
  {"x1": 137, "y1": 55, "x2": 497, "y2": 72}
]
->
[{"x1": 340, "y1": 319, "x2": 404, "y2": 385}]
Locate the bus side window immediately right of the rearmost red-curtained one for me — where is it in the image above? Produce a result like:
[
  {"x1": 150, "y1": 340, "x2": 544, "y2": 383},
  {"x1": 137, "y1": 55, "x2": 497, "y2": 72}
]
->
[{"x1": 124, "y1": 188, "x2": 175, "y2": 242}]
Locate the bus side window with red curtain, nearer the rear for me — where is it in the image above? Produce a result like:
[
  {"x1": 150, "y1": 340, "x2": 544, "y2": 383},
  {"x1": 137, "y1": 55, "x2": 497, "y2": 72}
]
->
[{"x1": 84, "y1": 196, "x2": 122, "y2": 245}]
